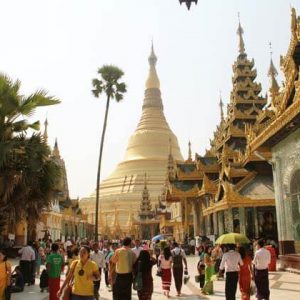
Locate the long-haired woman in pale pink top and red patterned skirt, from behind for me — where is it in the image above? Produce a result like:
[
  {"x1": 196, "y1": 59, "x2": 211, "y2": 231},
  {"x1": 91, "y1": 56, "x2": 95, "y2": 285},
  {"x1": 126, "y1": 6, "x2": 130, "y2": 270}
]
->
[{"x1": 158, "y1": 247, "x2": 172, "y2": 298}]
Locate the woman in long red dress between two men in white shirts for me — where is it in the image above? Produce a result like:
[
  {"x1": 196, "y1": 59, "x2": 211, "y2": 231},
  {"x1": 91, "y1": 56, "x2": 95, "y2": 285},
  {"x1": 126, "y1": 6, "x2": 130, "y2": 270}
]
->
[{"x1": 239, "y1": 247, "x2": 252, "y2": 300}]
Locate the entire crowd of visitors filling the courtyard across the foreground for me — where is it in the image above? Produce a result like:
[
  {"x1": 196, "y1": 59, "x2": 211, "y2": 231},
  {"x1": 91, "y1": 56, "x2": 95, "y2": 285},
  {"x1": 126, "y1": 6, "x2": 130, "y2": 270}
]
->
[{"x1": 0, "y1": 237, "x2": 271, "y2": 300}]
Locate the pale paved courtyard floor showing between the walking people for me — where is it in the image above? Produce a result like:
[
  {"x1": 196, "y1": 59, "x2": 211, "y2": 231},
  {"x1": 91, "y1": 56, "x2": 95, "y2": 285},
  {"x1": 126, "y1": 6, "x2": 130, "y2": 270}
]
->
[{"x1": 12, "y1": 257, "x2": 300, "y2": 300}]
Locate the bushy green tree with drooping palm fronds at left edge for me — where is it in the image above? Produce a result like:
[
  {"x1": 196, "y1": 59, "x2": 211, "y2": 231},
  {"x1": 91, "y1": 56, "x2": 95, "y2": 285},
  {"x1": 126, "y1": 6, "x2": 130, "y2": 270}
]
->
[{"x1": 0, "y1": 74, "x2": 60, "y2": 237}]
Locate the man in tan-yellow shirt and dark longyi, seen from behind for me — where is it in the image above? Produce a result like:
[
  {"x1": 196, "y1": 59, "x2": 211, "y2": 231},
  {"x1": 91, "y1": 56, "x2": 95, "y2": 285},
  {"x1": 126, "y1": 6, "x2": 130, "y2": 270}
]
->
[{"x1": 111, "y1": 237, "x2": 136, "y2": 300}]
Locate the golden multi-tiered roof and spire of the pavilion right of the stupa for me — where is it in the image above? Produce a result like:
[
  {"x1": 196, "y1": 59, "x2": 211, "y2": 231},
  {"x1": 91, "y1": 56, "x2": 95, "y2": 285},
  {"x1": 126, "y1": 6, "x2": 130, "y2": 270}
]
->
[{"x1": 167, "y1": 17, "x2": 275, "y2": 215}]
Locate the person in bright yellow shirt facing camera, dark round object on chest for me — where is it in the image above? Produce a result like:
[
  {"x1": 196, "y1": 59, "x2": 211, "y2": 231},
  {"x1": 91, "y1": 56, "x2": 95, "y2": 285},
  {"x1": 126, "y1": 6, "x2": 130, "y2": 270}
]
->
[{"x1": 57, "y1": 245, "x2": 100, "y2": 300}]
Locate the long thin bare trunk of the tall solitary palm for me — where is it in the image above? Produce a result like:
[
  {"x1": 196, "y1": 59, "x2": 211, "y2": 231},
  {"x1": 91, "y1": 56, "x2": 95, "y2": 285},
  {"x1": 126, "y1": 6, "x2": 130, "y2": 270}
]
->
[{"x1": 95, "y1": 95, "x2": 110, "y2": 241}]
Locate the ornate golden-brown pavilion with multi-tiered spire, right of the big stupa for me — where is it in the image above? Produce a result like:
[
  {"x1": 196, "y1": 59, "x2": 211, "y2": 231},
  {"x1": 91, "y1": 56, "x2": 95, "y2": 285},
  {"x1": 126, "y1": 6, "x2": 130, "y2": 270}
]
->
[{"x1": 165, "y1": 18, "x2": 277, "y2": 241}]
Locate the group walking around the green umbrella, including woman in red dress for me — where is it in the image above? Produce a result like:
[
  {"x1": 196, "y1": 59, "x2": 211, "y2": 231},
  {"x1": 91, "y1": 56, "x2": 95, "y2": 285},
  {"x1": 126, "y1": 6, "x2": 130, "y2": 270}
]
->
[{"x1": 197, "y1": 239, "x2": 272, "y2": 300}]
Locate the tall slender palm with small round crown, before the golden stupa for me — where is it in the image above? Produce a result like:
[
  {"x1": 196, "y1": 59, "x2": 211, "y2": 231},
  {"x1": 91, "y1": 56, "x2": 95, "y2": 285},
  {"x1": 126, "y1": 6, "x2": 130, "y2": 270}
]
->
[{"x1": 92, "y1": 65, "x2": 126, "y2": 241}]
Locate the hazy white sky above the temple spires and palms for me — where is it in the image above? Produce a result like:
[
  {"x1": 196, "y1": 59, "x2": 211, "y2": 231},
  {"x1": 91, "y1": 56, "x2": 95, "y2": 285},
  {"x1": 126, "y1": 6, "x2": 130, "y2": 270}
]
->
[{"x1": 0, "y1": 0, "x2": 300, "y2": 197}]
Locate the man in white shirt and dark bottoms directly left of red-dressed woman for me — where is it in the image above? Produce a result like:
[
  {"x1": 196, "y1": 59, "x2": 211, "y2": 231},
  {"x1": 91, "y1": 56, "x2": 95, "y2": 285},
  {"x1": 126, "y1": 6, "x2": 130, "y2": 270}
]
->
[{"x1": 220, "y1": 244, "x2": 243, "y2": 300}]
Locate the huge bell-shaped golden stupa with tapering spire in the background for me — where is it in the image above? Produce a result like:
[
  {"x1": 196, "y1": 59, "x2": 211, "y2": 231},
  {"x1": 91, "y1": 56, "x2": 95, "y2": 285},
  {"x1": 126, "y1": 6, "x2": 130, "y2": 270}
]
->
[{"x1": 80, "y1": 45, "x2": 183, "y2": 236}]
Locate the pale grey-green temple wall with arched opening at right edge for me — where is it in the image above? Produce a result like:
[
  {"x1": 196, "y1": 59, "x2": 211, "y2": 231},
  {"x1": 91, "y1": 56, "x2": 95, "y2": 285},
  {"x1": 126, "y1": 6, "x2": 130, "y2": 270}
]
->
[{"x1": 272, "y1": 129, "x2": 300, "y2": 254}]
